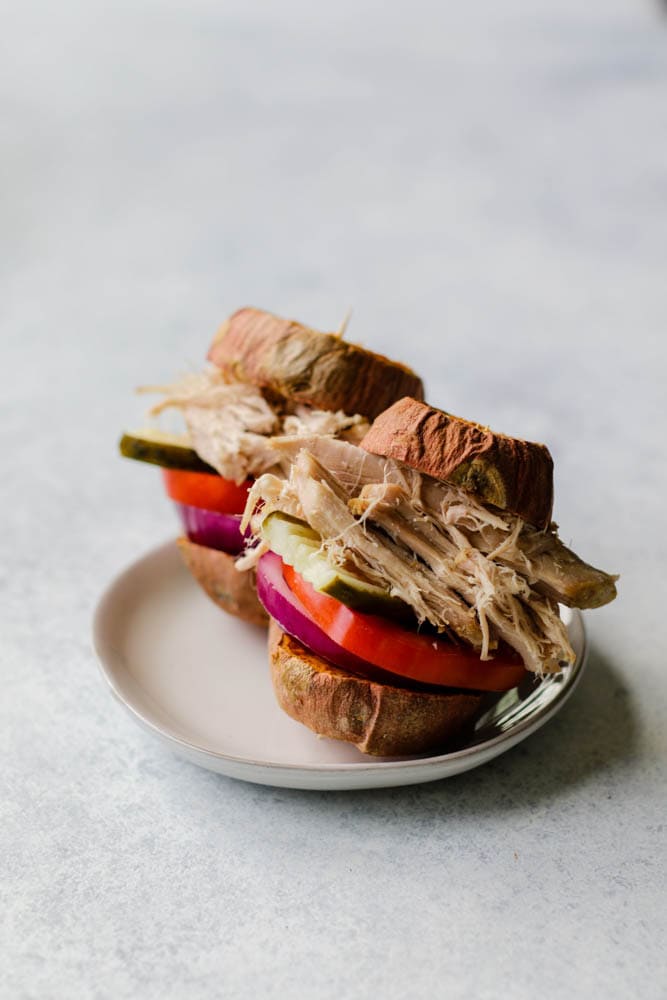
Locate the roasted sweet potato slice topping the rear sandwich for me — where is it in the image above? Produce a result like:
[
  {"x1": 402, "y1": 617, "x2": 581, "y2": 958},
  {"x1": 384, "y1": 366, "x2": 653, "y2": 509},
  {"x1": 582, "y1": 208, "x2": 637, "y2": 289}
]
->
[{"x1": 208, "y1": 308, "x2": 424, "y2": 420}]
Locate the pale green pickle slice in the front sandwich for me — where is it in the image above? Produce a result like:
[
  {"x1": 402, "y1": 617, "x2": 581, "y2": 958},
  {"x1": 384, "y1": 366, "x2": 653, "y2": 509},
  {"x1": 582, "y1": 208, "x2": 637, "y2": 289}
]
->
[{"x1": 261, "y1": 511, "x2": 413, "y2": 621}]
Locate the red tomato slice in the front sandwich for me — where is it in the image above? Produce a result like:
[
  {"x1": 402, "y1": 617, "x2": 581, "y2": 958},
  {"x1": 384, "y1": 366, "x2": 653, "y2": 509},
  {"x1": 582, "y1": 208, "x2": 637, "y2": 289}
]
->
[{"x1": 283, "y1": 564, "x2": 526, "y2": 691}]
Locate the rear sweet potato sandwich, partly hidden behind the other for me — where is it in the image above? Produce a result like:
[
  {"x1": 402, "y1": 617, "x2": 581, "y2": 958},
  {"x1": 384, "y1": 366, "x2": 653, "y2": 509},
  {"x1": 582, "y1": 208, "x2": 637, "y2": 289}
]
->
[{"x1": 120, "y1": 308, "x2": 423, "y2": 624}]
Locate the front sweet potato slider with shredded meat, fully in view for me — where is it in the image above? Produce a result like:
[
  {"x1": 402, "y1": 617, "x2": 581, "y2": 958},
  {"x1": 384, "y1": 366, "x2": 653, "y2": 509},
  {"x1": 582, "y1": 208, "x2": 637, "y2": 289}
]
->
[{"x1": 238, "y1": 398, "x2": 616, "y2": 755}]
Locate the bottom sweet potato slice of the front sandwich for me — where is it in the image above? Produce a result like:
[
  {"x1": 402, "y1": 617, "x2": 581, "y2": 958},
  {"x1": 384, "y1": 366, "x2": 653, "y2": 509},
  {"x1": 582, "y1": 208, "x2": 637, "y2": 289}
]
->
[{"x1": 269, "y1": 621, "x2": 485, "y2": 757}]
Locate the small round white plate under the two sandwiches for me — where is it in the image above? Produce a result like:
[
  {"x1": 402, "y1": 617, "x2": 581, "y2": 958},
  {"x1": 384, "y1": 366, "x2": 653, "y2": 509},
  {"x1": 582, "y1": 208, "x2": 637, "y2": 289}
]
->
[{"x1": 94, "y1": 542, "x2": 586, "y2": 789}]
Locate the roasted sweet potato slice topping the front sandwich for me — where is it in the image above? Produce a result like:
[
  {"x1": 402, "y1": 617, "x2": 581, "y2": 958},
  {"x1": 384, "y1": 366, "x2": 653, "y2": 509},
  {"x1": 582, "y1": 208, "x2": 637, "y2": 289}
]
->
[{"x1": 361, "y1": 398, "x2": 553, "y2": 529}]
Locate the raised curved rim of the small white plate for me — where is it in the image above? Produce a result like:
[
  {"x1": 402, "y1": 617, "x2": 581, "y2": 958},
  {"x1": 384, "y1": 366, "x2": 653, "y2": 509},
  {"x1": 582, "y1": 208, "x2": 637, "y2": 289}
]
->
[{"x1": 92, "y1": 538, "x2": 589, "y2": 787}]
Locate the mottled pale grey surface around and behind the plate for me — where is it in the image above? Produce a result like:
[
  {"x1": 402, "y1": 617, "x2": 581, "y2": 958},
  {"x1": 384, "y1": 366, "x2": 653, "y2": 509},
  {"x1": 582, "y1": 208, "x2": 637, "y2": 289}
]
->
[{"x1": 0, "y1": 0, "x2": 667, "y2": 1000}]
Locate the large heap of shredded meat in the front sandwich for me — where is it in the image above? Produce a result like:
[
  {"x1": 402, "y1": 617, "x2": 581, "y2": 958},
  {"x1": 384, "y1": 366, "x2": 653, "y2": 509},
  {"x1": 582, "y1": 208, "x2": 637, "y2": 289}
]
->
[{"x1": 243, "y1": 437, "x2": 615, "y2": 675}]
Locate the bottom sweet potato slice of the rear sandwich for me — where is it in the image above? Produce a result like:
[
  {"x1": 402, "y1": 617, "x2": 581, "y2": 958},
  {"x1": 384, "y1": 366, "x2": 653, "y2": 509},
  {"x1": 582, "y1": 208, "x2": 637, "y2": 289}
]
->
[{"x1": 178, "y1": 538, "x2": 269, "y2": 625}]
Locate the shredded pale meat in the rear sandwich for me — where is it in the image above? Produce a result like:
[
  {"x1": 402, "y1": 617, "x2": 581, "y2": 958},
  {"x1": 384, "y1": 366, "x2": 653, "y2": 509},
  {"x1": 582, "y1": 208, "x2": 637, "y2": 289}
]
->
[{"x1": 143, "y1": 368, "x2": 369, "y2": 483}]
